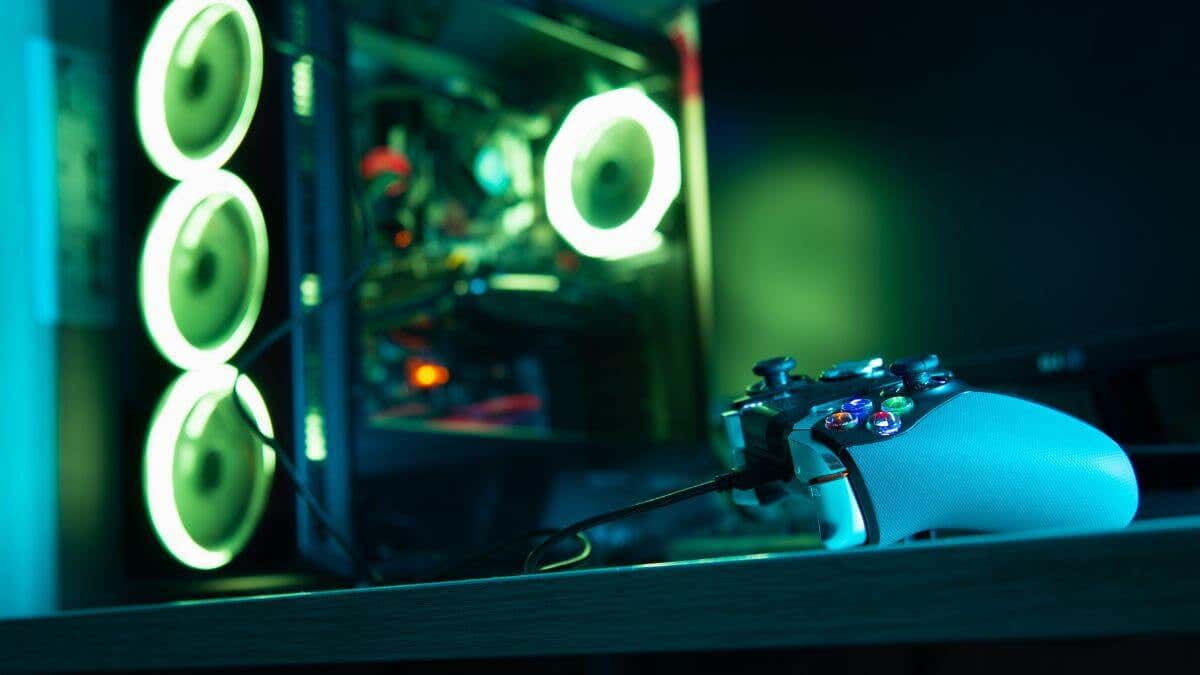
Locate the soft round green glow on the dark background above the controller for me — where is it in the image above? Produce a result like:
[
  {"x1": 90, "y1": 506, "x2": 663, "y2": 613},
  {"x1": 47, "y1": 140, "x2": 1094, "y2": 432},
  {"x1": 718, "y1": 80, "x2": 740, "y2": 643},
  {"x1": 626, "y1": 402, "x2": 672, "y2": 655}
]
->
[{"x1": 713, "y1": 149, "x2": 922, "y2": 396}]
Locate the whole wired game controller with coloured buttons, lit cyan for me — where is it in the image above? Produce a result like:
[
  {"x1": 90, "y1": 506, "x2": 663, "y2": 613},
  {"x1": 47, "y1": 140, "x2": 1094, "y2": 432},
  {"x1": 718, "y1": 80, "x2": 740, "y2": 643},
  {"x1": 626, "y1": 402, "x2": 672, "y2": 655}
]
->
[{"x1": 724, "y1": 354, "x2": 1138, "y2": 549}]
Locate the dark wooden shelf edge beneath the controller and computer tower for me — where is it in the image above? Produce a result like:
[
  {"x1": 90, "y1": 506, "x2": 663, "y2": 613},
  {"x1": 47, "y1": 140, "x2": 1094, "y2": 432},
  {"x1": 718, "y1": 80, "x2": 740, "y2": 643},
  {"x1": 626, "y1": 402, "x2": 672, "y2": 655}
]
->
[{"x1": 0, "y1": 518, "x2": 1200, "y2": 670}]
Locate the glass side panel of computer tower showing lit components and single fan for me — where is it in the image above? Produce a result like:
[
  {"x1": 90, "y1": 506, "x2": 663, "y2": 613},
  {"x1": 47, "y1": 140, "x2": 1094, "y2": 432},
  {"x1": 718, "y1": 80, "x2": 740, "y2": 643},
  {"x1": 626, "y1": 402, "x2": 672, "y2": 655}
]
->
[{"x1": 348, "y1": 2, "x2": 703, "y2": 451}]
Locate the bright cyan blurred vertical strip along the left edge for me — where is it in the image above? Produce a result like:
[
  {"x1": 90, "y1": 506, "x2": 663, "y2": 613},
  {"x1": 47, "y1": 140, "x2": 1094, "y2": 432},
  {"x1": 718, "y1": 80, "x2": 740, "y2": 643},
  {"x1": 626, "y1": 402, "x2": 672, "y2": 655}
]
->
[{"x1": 0, "y1": 2, "x2": 59, "y2": 619}]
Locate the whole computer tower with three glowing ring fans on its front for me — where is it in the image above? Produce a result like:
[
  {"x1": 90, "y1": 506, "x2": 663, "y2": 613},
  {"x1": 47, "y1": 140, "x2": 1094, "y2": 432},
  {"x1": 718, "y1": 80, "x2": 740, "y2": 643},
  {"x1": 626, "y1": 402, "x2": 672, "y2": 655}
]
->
[{"x1": 55, "y1": 0, "x2": 712, "y2": 607}]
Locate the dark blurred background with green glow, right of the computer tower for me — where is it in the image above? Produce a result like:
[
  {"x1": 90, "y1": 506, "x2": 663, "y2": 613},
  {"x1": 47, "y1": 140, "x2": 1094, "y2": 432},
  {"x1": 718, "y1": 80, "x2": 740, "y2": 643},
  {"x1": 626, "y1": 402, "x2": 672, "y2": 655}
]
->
[{"x1": 702, "y1": 1, "x2": 1200, "y2": 395}]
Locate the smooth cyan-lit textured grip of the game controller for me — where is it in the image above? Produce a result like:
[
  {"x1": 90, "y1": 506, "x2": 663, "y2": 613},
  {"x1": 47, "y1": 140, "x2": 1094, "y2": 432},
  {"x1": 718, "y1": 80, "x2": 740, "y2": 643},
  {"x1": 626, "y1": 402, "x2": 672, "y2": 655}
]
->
[{"x1": 846, "y1": 392, "x2": 1138, "y2": 544}]
